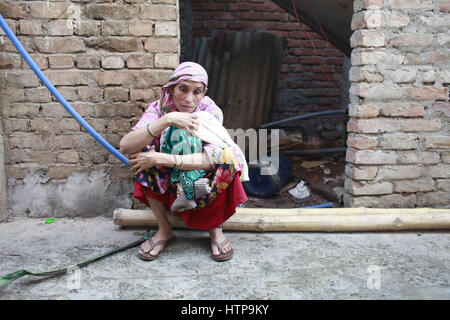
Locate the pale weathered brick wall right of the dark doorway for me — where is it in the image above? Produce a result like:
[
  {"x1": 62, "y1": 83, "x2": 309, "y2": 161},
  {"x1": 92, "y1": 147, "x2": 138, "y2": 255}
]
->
[{"x1": 345, "y1": 0, "x2": 450, "y2": 207}]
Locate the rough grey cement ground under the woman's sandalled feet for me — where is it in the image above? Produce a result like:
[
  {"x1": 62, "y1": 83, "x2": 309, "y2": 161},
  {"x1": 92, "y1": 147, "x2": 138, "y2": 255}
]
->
[{"x1": 0, "y1": 218, "x2": 450, "y2": 300}]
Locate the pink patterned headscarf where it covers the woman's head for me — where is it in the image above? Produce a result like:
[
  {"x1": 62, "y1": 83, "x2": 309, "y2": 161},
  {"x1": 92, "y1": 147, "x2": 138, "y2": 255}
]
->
[{"x1": 159, "y1": 62, "x2": 208, "y2": 113}]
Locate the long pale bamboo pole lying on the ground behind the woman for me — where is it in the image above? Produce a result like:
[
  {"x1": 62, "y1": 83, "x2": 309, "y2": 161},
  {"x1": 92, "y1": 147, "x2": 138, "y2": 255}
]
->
[{"x1": 113, "y1": 208, "x2": 450, "y2": 232}]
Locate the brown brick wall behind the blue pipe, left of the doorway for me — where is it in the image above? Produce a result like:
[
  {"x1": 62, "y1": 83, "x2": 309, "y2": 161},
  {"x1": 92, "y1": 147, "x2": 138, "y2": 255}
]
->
[{"x1": 0, "y1": 0, "x2": 179, "y2": 216}]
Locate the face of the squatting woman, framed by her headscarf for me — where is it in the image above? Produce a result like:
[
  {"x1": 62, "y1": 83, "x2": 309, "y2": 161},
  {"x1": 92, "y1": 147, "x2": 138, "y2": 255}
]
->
[{"x1": 169, "y1": 80, "x2": 207, "y2": 112}]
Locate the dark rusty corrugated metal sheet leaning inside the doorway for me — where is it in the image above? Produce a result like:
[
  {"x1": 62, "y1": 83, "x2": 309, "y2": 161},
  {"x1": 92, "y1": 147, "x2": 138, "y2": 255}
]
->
[{"x1": 192, "y1": 32, "x2": 286, "y2": 129}]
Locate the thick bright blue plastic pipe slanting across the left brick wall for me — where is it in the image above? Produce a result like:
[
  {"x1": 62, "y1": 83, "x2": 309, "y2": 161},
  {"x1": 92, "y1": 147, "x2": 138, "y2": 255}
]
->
[{"x1": 0, "y1": 14, "x2": 131, "y2": 167}]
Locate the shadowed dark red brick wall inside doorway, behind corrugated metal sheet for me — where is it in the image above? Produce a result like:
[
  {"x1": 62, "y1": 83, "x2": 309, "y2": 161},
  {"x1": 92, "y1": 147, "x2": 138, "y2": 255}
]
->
[{"x1": 184, "y1": 0, "x2": 348, "y2": 136}]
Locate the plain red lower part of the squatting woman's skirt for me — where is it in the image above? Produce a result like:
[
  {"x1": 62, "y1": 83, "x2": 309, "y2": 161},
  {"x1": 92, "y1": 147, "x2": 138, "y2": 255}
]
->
[{"x1": 134, "y1": 172, "x2": 247, "y2": 230}]
